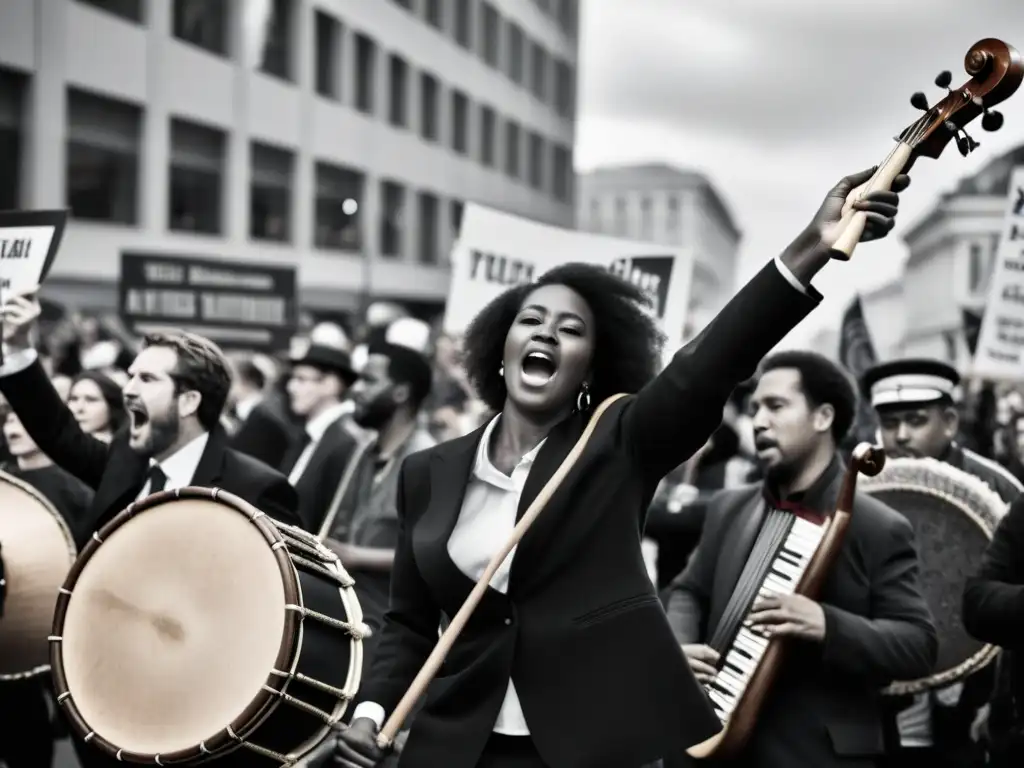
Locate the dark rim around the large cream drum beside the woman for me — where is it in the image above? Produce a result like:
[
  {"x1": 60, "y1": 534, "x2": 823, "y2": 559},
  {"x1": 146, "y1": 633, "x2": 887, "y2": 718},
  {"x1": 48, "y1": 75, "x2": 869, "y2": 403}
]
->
[{"x1": 49, "y1": 486, "x2": 303, "y2": 765}]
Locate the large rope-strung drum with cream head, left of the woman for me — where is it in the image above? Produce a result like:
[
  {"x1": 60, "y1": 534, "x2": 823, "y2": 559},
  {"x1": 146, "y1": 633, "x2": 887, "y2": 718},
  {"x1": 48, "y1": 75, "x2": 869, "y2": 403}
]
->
[{"x1": 50, "y1": 487, "x2": 369, "y2": 768}]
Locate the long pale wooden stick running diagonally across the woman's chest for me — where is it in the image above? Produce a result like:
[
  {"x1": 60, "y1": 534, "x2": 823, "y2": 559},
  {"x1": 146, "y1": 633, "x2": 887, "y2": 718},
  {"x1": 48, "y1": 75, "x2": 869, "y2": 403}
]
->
[{"x1": 377, "y1": 394, "x2": 626, "y2": 750}]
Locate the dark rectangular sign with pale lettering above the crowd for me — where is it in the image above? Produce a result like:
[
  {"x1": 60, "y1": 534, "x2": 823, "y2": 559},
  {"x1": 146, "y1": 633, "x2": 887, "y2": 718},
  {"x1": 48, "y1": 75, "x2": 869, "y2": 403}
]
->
[{"x1": 120, "y1": 253, "x2": 298, "y2": 351}]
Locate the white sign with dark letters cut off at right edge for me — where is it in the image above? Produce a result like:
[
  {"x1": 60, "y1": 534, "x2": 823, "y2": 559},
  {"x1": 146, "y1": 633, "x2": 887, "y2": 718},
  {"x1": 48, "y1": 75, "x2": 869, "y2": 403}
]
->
[{"x1": 972, "y1": 166, "x2": 1024, "y2": 380}]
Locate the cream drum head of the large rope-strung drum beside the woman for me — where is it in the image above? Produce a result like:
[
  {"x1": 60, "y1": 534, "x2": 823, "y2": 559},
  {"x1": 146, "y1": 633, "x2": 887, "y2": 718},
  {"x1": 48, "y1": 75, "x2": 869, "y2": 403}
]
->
[{"x1": 61, "y1": 498, "x2": 286, "y2": 755}]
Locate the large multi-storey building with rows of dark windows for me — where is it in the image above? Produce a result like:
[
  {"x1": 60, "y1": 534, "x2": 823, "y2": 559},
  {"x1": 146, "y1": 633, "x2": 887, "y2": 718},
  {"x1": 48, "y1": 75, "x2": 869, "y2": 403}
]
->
[{"x1": 0, "y1": 0, "x2": 579, "y2": 323}]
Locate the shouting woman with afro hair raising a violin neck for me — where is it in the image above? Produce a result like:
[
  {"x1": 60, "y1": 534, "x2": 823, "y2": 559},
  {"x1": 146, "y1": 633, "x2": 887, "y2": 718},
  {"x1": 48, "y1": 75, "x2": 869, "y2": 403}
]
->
[{"x1": 335, "y1": 169, "x2": 909, "y2": 768}]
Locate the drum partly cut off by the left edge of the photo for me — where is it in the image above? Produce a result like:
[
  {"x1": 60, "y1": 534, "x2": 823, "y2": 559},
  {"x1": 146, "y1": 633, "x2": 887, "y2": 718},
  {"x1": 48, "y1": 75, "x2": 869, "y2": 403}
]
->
[{"x1": 0, "y1": 472, "x2": 76, "y2": 684}]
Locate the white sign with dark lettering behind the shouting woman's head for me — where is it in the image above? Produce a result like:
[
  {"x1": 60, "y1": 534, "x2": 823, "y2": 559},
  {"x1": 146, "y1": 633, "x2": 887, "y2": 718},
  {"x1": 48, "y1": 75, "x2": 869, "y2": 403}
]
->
[{"x1": 444, "y1": 204, "x2": 693, "y2": 358}]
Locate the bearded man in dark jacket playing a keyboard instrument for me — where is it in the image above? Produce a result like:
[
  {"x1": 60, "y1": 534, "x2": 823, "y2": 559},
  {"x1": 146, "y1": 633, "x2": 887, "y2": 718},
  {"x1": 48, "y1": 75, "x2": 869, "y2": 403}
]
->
[{"x1": 668, "y1": 351, "x2": 938, "y2": 768}]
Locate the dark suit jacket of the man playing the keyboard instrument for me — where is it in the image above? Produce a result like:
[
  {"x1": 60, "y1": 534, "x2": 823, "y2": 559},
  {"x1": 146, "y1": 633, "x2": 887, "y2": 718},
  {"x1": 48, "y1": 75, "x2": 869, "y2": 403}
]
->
[{"x1": 668, "y1": 457, "x2": 938, "y2": 768}]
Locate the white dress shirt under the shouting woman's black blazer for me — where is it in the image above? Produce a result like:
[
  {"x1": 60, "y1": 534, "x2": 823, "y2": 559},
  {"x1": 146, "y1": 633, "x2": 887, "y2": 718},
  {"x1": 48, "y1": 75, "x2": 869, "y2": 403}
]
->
[{"x1": 352, "y1": 415, "x2": 544, "y2": 736}]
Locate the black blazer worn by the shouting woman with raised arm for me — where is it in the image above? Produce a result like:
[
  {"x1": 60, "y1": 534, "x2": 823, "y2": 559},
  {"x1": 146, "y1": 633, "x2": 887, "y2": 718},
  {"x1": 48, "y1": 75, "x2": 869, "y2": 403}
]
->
[{"x1": 360, "y1": 264, "x2": 817, "y2": 768}]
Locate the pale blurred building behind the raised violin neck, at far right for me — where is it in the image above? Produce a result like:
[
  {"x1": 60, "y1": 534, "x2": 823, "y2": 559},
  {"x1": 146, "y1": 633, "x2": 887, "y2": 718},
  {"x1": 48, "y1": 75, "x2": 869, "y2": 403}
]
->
[{"x1": 900, "y1": 145, "x2": 1024, "y2": 370}]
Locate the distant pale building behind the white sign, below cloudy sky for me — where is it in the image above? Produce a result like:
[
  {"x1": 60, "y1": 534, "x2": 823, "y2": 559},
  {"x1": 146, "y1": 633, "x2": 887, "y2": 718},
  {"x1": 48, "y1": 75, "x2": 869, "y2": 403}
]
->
[{"x1": 577, "y1": 164, "x2": 740, "y2": 338}]
